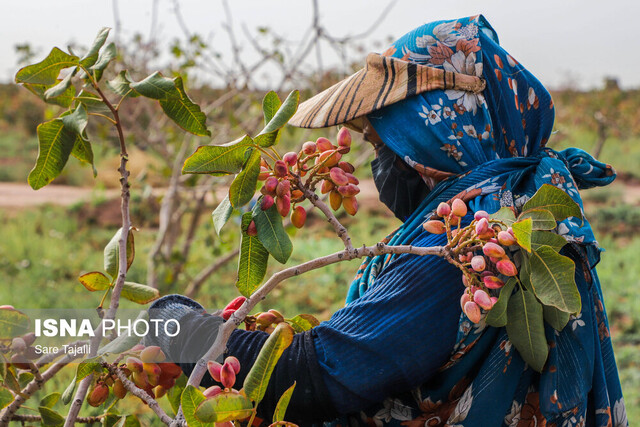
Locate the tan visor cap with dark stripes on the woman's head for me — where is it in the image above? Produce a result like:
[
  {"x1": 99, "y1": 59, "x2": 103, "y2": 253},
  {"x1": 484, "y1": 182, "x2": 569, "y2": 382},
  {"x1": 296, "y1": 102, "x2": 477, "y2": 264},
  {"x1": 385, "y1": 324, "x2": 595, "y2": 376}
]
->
[{"x1": 289, "y1": 53, "x2": 485, "y2": 131}]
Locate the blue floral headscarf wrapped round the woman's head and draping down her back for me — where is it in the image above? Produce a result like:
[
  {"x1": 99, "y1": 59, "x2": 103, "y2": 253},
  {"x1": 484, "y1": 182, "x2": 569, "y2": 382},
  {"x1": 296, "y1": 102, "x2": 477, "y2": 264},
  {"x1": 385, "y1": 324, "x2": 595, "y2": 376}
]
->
[{"x1": 347, "y1": 15, "x2": 627, "y2": 426}]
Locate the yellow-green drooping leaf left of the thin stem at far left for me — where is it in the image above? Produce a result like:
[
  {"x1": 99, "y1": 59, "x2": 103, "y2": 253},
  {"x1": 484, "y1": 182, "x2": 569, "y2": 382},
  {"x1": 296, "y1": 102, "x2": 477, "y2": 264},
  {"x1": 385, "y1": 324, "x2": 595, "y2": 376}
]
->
[{"x1": 28, "y1": 119, "x2": 76, "y2": 190}]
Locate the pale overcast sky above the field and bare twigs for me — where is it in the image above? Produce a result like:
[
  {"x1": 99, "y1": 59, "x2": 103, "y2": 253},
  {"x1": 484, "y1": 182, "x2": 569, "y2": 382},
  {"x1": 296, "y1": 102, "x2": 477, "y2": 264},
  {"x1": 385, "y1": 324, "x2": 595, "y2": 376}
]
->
[{"x1": 0, "y1": 0, "x2": 640, "y2": 88}]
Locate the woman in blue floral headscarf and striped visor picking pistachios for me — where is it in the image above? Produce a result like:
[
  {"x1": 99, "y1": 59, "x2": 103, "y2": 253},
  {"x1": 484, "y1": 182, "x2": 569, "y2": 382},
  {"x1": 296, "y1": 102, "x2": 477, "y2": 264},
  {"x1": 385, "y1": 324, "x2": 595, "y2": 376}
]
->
[{"x1": 152, "y1": 16, "x2": 627, "y2": 426}]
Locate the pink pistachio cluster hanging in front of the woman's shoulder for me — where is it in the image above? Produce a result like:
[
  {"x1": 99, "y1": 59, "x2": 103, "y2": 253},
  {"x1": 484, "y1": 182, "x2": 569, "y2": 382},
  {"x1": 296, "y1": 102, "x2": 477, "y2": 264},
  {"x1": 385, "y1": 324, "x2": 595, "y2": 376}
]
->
[{"x1": 423, "y1": 199, "x2": 518, "y2": 323}]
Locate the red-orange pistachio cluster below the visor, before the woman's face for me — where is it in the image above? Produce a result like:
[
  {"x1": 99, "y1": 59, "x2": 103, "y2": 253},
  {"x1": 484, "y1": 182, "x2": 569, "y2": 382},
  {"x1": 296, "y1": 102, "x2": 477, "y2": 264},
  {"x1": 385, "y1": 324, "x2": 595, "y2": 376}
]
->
[{"x1": 247, "y1": 128, "x2": 360, "y2": 236}]
